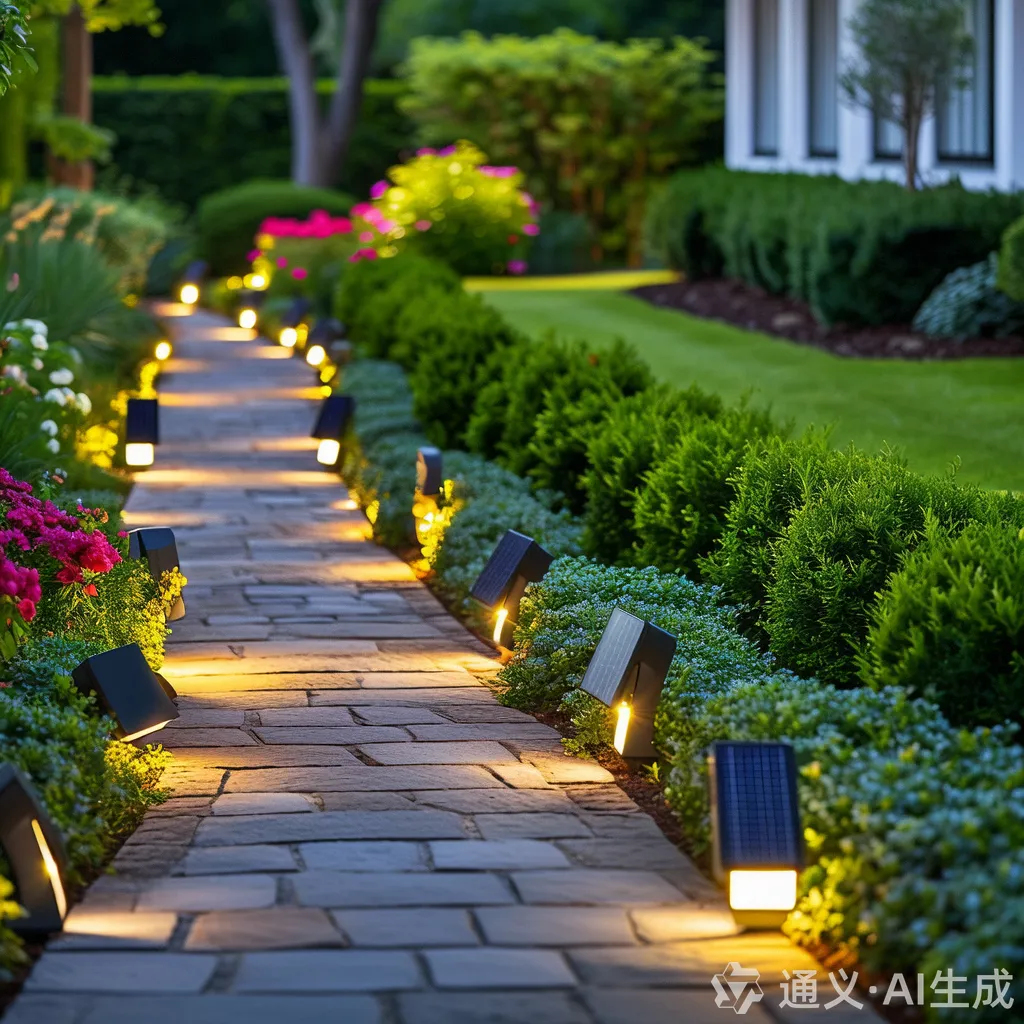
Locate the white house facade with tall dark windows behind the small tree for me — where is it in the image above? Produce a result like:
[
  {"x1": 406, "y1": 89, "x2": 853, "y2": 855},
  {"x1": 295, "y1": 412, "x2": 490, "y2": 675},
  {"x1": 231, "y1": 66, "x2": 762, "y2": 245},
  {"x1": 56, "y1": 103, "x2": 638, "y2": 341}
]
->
[{"x1": 725, "y1": 0, "x2": 1024, "y2": 190}]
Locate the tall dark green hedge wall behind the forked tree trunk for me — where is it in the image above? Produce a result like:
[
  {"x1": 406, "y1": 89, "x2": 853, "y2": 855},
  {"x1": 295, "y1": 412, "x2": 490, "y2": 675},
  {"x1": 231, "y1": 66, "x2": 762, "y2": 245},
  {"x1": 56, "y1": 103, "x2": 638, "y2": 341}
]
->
[{"x1": 92, "y1": 75, "x2": 412, "y2": 208}]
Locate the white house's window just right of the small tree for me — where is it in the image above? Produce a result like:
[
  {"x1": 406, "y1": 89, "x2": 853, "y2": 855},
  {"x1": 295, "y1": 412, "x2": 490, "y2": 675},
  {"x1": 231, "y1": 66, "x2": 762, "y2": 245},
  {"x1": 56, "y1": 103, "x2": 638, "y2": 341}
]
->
[{"x1": 936, "y1": 0, "x2": 995, "y2": 164}]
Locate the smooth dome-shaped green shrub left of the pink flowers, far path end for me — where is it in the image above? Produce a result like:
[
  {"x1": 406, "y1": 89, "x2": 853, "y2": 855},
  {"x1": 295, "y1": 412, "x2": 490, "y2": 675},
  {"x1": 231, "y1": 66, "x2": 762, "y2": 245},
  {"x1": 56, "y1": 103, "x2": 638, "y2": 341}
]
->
[{"x1": 196, "y1": 178, "x2": 353, "y2": 275}]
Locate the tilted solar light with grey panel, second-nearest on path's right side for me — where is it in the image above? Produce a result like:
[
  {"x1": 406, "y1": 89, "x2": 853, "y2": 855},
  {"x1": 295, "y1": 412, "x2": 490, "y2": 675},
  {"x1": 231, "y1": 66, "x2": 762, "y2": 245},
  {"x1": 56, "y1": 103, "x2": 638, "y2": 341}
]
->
[{"x1": 583, "y1": 608, "x2": 676, "y2": 760}]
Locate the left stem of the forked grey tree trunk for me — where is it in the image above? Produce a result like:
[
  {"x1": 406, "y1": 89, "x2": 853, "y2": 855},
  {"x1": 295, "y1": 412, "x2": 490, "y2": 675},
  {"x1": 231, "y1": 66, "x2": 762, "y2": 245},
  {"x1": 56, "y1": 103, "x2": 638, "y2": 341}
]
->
[{"x1": 267, "y1": 0, "x2": 327, "y2": 185}]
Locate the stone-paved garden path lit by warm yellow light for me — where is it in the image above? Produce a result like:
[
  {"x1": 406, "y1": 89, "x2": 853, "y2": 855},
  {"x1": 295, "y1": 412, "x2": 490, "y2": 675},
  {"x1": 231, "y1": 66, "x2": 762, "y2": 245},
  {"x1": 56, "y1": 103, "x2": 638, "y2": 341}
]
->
[{"x1": 5, "y1": 313, "x2": 870, "y2": 1024}]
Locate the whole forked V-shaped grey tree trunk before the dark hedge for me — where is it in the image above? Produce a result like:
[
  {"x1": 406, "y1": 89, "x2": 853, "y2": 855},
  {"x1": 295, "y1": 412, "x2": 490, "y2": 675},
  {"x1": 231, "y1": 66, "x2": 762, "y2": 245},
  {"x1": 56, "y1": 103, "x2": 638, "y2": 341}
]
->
[{"x1": 267, "y1": 0, "x2": 384, "y2": 185}]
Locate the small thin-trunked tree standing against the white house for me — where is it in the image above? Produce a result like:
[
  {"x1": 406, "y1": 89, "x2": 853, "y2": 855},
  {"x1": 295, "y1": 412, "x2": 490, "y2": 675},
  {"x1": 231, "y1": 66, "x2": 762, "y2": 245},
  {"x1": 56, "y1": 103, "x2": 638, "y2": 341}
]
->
[{"x1": 841, "y1": 0, "x2": 972, "y2": 191}]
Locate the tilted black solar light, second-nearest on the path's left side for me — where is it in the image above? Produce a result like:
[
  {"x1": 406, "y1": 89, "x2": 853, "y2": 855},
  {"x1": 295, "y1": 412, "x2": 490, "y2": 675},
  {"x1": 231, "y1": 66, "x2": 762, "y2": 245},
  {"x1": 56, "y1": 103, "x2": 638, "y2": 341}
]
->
[{"x1": 72, "y1": 643, "x2": 178, "y2": 742}]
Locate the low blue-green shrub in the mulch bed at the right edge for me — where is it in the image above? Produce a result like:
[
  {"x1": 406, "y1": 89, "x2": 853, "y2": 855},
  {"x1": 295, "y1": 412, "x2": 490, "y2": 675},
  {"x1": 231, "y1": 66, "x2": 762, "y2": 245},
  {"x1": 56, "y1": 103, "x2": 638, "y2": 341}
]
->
[{"x1": 913, "y1": 253, "x2": 1024, "y2": 341}]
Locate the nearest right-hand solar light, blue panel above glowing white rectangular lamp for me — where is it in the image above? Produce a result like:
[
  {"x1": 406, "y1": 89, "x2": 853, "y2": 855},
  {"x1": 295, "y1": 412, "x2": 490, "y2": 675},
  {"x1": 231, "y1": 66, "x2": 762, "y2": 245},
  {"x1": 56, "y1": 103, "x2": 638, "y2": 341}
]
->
[{"x1": 708, "y1": 741, "x2": 804, "y2": 928}]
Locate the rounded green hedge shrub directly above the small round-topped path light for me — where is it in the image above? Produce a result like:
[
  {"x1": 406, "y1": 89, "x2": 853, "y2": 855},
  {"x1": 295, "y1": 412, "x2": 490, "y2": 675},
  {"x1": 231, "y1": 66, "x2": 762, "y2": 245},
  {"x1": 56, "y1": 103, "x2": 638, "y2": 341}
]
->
[{"x1": 404, "y1": 292, "x2": 522, "y2": 447}]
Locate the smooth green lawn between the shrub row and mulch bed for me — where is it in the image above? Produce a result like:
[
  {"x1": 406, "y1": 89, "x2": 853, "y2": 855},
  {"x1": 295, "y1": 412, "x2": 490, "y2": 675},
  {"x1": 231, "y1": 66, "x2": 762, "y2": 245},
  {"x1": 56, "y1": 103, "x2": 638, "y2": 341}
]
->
[{"x1": 482, "y1": 291, "x2": 1024, "y2": 490}]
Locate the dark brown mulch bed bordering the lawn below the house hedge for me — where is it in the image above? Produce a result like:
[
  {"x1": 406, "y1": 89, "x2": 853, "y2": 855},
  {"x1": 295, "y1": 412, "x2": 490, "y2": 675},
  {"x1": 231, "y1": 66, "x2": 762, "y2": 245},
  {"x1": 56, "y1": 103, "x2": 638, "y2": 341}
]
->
[{"x1": 630, "y1": 279, "x2": 1024, "y2": 359}]
